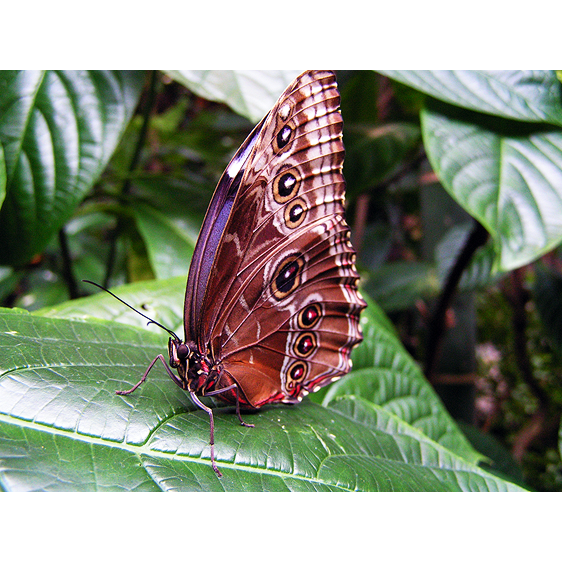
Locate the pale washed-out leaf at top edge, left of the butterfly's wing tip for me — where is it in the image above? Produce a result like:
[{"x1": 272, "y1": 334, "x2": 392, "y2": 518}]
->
[{"x1": 165, "y1": 70, "x2": 302, "y2": 123}]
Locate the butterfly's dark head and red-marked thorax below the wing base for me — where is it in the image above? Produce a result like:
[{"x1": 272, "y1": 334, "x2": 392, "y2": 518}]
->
[{"x1": 168, "y1": 338, "x2": 220, "y2": 394}]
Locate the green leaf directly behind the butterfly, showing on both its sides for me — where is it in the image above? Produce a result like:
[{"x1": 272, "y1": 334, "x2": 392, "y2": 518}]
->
[{"x1": 36, "y1": 277, "x2": 483, "y2": 462}]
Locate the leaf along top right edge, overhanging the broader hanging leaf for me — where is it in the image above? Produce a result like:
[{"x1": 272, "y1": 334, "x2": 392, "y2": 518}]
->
[{"x1": 380, "y1": 70, "x2": 562, "y2": 125}]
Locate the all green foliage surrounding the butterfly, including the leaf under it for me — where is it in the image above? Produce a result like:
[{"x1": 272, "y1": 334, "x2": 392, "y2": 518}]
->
[{"x1": 0, "y1": 71, "x2": 562, "y2": 490}]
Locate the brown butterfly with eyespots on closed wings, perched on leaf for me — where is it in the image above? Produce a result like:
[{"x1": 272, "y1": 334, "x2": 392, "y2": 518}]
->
[{"x1": 102, "y1": 71, "x2": 366, "y2": 476}]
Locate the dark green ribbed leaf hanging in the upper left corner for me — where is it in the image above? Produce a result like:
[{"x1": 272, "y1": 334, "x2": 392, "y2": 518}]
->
[{"x1": 0, "y1": 70, "x2": 144, "y2": 264}]
